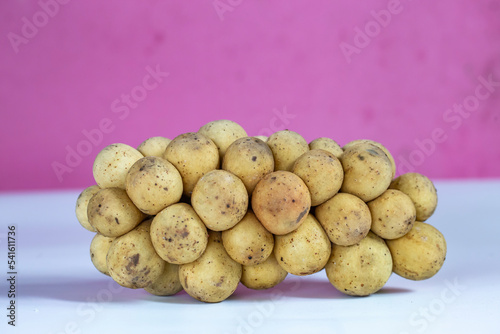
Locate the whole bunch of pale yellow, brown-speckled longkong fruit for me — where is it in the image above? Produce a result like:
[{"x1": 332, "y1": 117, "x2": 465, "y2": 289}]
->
[{"x1": 76, "y1": 120, "x2": 446, "y2": 302}]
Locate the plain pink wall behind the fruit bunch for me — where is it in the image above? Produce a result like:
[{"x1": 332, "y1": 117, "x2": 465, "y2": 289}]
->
[{"x1": 0, "y1": 0, "x2": 500, "y2": 190}]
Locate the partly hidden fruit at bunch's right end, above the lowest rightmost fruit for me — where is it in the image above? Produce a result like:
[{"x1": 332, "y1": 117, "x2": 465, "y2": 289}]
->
[{"x1": 389, "y1": 173, "x2": 438, "y2": 221}]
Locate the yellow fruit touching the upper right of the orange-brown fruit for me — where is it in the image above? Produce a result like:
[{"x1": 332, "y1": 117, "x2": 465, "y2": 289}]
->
[{"x1": 292, "y1": 150, "x2": 344, "y2": 206}]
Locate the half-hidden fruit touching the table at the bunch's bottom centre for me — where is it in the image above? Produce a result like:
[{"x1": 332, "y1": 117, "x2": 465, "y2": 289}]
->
[{"x1": 241, "y1": 250, "x2": 288, "y2": 290}]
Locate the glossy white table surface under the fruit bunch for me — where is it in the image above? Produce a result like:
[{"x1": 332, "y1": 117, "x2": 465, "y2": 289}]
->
[{"x1": 0, "y1": 180, "x2": 500, "y2": 334}]
